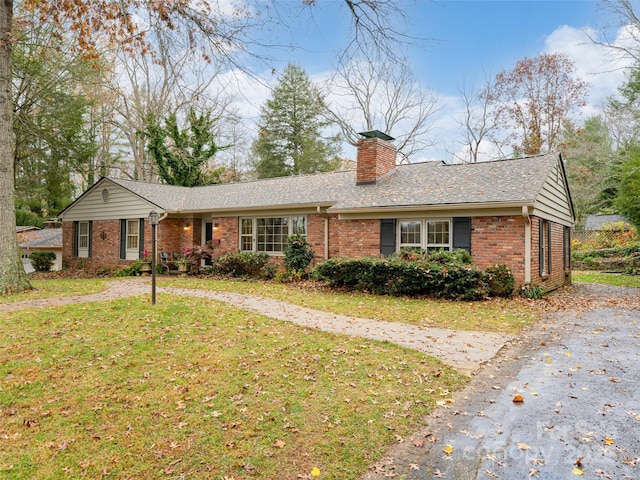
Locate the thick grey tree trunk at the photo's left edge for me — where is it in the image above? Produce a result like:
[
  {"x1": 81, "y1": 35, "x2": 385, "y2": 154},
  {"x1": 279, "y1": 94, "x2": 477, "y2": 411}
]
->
[{"x1": 0, "y1": 0, "x2": 31, "y2": 295}]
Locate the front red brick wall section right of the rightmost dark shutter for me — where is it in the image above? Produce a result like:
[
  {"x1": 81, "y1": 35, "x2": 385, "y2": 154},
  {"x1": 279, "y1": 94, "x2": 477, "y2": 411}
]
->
[{"x1": 471, "y1": 216, "x2": 525, "y2": 285}]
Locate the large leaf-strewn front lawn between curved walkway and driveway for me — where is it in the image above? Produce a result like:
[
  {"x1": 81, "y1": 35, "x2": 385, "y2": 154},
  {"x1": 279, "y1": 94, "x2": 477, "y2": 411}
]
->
[{"x1": 0, "y1": 294, "x2": 467, "y2": 480}]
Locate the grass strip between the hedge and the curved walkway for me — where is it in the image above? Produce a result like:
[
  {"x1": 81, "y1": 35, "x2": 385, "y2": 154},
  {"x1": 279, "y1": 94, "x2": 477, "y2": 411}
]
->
[{"x1": 158, "y1": 277, "x2": 539, "y2": 333}]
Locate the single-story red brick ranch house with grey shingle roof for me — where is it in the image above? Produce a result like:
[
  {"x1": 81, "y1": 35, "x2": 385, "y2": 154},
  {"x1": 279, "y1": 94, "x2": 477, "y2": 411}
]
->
[{"x1": 60, "y1": 132, "x2": 574, "y2": 289}]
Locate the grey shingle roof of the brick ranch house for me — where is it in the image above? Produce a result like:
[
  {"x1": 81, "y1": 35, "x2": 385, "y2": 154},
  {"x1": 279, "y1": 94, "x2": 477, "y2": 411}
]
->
[{"x1": 104, "y1": 154, "x2": 559, "y2": 212}]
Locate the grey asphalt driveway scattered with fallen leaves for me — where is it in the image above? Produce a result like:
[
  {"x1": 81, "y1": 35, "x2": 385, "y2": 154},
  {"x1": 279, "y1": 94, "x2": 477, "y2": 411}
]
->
[{"x1": 365, "y1": 286, "x2": 640, "y2": 480}]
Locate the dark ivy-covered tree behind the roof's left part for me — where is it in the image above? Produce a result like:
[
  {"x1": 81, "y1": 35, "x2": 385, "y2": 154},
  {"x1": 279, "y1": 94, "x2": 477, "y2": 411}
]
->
[{"x1": 141, "y1": 108, "x2": 223, "y2": 187}]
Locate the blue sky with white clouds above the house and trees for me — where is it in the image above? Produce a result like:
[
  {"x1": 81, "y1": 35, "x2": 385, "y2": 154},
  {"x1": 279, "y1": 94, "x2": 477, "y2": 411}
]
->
[{"x1": 222, "y1": 0, "x2": 627, "y2": 160}]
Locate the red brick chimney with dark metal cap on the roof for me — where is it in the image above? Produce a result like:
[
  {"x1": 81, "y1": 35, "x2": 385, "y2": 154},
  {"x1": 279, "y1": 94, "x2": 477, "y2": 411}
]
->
[{"x1": 356, "y1": 130, "x2": 396, "y2": 185}]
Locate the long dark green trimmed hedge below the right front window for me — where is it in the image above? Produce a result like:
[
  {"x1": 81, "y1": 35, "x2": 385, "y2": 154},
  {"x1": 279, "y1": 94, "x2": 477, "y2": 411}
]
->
[{"x1": 312, "y1": 251, "x2": 504, "y2": 300}]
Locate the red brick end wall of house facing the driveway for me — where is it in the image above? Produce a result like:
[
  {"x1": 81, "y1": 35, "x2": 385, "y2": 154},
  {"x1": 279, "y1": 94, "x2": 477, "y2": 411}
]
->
[{"x1": 531, "y1": 217, "x2": 571, "y2": 290}]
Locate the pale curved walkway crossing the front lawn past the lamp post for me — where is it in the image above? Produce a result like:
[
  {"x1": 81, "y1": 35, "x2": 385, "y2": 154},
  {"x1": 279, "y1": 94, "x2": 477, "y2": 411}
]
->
[{"x1": 0, "y1": 278, "x2": 513, "y2": 374}]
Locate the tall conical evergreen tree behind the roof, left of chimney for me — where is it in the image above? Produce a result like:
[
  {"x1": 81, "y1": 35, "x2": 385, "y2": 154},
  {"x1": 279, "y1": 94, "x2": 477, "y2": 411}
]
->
[{"x1": 252, "y1": 64, "x2": 340, "y2": 178}]
